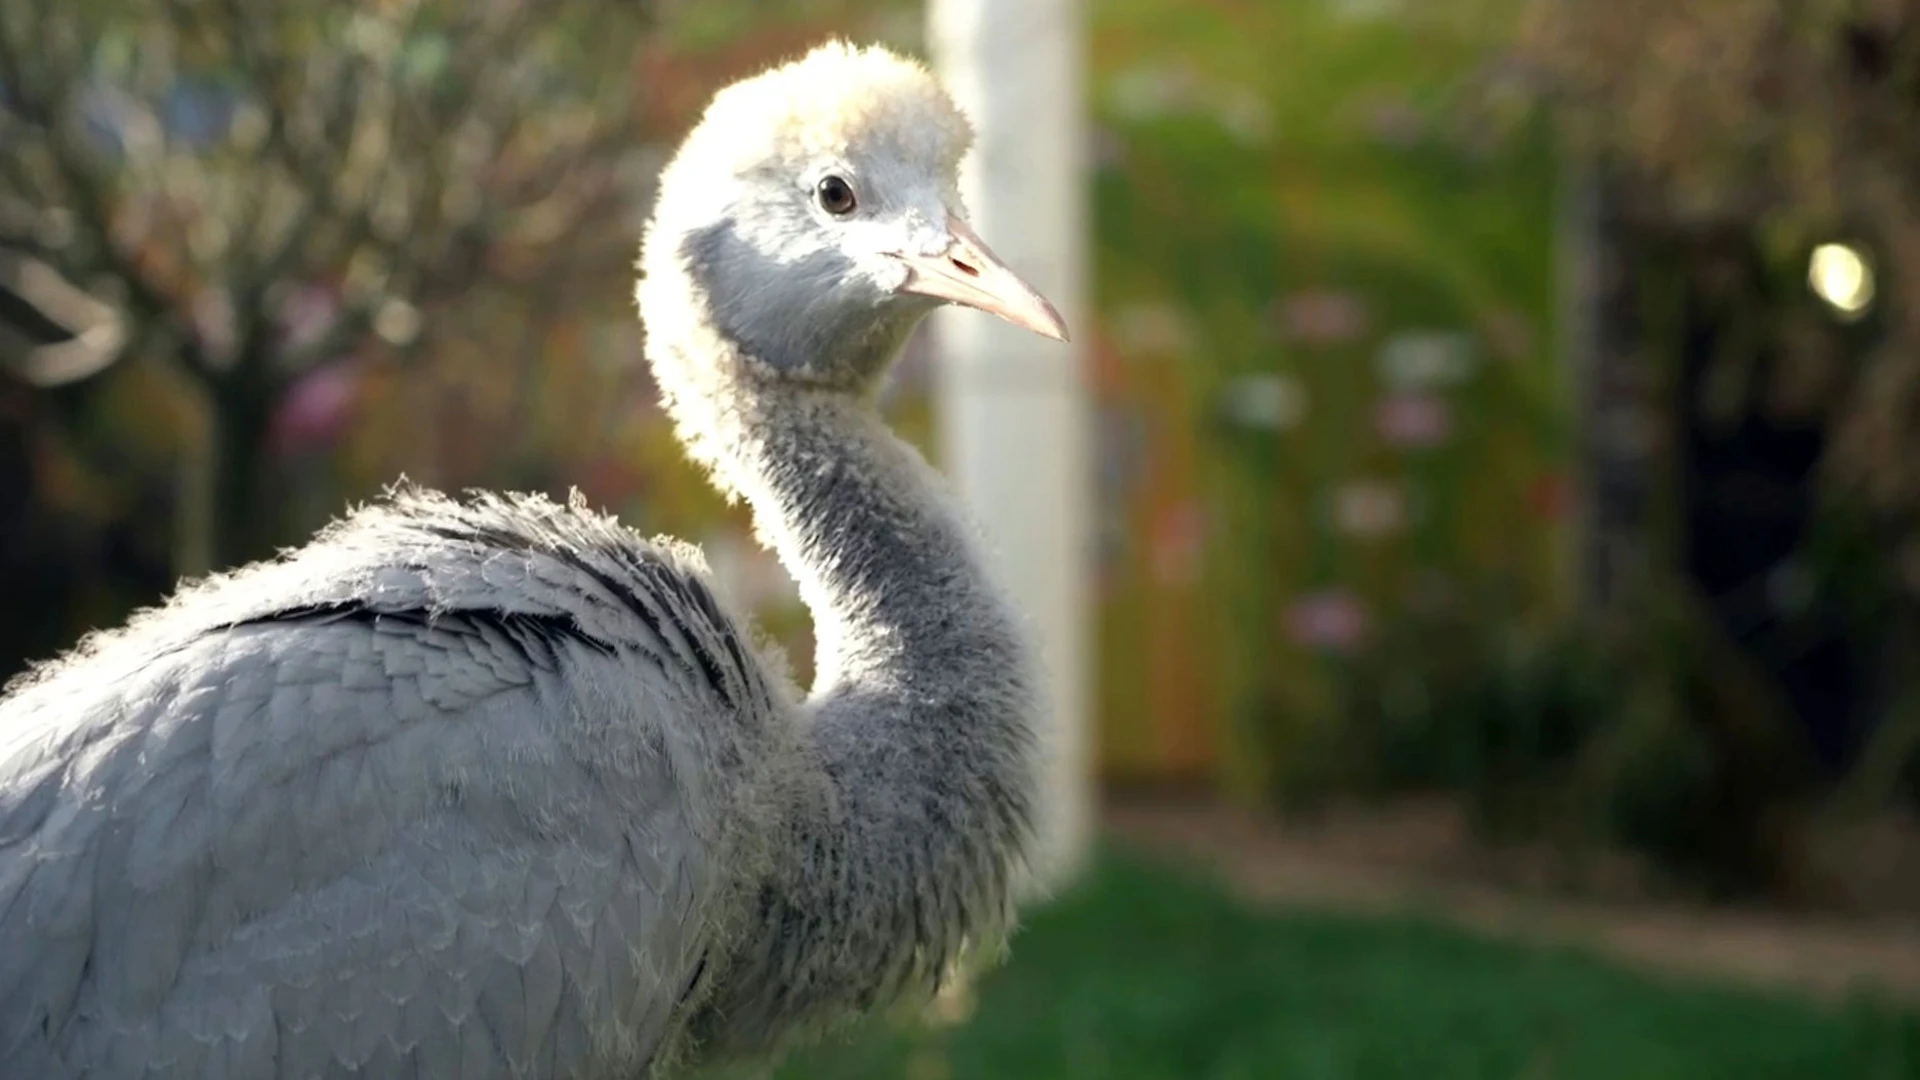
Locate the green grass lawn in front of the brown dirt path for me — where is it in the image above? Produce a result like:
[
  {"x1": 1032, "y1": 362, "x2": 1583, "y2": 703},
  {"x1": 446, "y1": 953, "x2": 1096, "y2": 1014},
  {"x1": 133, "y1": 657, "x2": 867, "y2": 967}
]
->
[{"x1": 721, "y1": 857, "x2": 1920, "y2": 1080}]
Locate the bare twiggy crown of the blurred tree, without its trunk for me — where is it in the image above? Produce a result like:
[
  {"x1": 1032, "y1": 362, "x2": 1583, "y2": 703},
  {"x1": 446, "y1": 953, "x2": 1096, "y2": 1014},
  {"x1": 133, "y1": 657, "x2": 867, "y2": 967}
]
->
[{"x1": 0, "y1": 0, "x2": 652, "y2": 393}]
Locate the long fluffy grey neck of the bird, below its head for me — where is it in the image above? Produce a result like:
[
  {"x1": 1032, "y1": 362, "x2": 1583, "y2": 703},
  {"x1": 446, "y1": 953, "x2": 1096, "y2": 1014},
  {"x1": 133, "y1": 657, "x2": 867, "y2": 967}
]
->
[{"x1": 641, "y1": 299, "x2": 1039, "y2": 1049}]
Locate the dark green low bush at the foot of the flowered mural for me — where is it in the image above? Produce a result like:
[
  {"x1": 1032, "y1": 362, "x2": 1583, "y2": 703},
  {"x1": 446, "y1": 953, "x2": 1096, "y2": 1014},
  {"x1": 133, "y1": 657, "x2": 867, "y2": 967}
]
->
[{"x1": 1286, "y1": 582, "x2": 1811, "y2": 896}]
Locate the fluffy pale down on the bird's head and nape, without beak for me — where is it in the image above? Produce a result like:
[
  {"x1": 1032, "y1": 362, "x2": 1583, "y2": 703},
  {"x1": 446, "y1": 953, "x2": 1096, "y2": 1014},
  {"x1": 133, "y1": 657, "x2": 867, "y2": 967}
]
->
[{"x1": 636, "y1": 40, "x2": 973, "y2": 488}]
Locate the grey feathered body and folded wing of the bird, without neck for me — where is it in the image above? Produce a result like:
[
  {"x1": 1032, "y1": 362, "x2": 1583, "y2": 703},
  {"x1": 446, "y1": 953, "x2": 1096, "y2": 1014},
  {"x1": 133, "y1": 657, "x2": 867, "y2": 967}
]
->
[{"x1": 0, "y1": 486, "x2": 772, "y2": 1080}]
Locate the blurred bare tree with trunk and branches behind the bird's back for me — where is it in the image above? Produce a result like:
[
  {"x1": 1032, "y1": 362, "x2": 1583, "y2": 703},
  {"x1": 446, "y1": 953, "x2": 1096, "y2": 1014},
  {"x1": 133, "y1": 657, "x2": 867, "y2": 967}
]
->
[{"x1": 0, "y1": 0, "x2": 645, "y2": 571}]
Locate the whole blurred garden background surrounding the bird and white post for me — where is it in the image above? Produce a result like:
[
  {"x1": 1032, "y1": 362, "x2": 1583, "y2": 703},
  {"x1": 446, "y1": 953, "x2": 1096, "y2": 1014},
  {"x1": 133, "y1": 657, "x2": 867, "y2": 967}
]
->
[{"x1": 0, "y1": 0, "x2": 1920, "y2": 1080}]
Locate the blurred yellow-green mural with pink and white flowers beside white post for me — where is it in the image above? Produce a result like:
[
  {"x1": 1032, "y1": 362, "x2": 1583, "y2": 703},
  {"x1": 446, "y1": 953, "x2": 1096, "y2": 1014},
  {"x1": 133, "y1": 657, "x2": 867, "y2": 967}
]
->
[{"x1": 1094, "y1": 0, "x2": 1571, "y2": 792}]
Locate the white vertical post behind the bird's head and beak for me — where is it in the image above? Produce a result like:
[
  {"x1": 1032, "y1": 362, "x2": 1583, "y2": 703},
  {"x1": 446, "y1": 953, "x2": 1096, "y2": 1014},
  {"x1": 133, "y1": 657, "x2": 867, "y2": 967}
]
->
[{"x1": 927, "y1": 0, "x2": 1094, "y2": 888}]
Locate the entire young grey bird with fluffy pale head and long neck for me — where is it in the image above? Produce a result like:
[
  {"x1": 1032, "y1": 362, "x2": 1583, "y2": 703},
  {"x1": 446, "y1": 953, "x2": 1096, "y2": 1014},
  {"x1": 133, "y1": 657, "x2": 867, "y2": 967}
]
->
[{"x1": 0, "y1": 44, "x2": 1064, "y2": 1080}]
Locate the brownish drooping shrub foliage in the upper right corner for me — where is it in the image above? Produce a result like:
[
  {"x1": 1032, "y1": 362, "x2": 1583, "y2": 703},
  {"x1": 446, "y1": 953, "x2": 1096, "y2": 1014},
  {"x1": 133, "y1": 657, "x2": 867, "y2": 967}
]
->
[{"x1": 1521, "y1": 0, "x2": 1920, "y2": 572}]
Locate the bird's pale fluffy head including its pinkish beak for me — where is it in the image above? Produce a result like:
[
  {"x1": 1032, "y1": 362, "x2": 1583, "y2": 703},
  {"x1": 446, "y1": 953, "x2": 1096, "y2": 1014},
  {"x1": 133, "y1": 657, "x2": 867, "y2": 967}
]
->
[{"x1": 641, "y1": 42, "x2": 1068, "y2": 388}]
